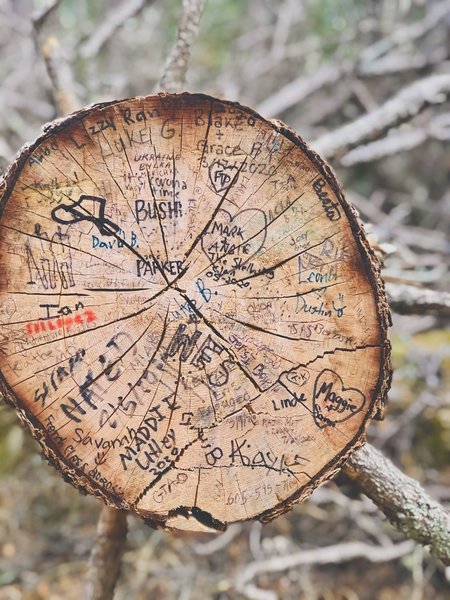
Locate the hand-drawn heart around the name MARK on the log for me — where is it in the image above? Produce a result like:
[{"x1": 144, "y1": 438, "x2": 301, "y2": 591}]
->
[{"x1": 201, "y1": 208, "x2": 267, "y2": 267}]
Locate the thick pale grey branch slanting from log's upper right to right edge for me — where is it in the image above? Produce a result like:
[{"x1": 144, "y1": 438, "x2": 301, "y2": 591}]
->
[{"x1": 312, "y1": 75, "x2": 450, "y2": 158}]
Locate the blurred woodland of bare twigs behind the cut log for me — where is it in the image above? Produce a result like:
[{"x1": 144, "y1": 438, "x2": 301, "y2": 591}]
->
[{"x1": 0, "y1": 0, "x2": 450, "y2": 600}]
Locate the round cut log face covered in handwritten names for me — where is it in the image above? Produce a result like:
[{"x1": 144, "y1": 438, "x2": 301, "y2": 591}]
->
[{"x1": 0, "y1": 94, "x2": 390, "y2": 531}]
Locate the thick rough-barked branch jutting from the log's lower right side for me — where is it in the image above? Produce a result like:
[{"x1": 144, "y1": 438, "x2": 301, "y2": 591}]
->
[{"x1": 342, "y1": 444, "x2": 450, "y2": 565}]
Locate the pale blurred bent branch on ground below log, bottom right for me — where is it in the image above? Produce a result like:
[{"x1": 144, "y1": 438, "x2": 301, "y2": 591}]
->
[{"x1": 235, "y1": 541, "x2": 414, "y2": 600}]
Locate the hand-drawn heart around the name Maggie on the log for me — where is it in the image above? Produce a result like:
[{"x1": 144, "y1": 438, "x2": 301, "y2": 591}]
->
[{"x1": 313, "y1": 369, "x2": 366, "y2": 429}]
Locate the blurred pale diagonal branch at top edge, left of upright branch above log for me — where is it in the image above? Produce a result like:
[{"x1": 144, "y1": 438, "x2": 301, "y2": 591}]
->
[{"x1": 80, "y1": 0, "x2": 153, "y2": 59}]
